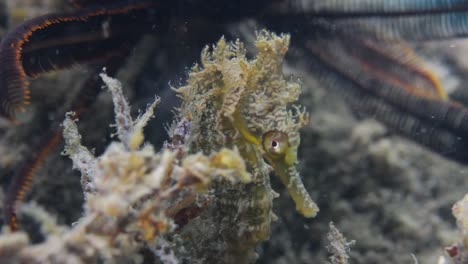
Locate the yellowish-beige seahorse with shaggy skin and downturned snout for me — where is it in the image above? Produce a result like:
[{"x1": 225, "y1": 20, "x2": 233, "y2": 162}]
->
[{"x1": 170, "y1": 31, "x2": 318, "y2": 263}]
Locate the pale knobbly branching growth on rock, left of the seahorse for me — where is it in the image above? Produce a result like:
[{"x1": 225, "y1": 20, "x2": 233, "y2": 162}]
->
[{"x1": 0, "y1": 73, "x2": 250, "y2": 263}]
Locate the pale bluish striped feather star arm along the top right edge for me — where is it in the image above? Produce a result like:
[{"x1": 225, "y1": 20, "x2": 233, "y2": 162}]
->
[{"x1": 264, "y1": 0, "x2": 468, "y2": 41}]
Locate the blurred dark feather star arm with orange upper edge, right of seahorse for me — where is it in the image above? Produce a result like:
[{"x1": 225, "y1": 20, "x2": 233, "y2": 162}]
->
[{"x1": 306, "y1": 38, "x2": 468, "y2": 163}]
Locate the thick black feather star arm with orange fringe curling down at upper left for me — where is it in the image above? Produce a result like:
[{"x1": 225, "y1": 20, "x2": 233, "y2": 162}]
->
[{"x1": 0, "y1": 1, "x2": 157, "y2": 119}]
